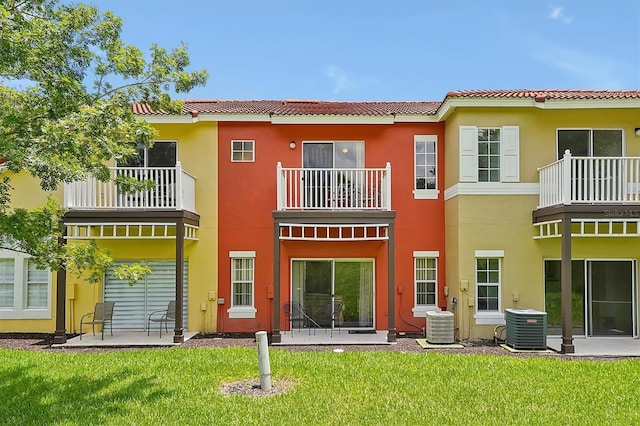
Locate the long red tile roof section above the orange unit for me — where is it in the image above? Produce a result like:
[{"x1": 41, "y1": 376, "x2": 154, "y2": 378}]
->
[{"x1": 133, "y1": 100, "x2": 440, "y2": 117}]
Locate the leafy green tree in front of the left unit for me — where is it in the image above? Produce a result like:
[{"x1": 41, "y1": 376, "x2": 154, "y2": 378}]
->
[{"x1": 0, "y1": 0, "x2": 208, "y2": 282}]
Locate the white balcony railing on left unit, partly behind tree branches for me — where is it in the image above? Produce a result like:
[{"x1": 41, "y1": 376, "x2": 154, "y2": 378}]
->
[{"x1": 64, "y1": 162, "x2": 196, "y2": 211}]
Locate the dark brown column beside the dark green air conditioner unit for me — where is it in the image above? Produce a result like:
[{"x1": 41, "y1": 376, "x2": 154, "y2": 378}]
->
[{"x1": 560, "y1": 213, "x2": 575, "y2": 354}]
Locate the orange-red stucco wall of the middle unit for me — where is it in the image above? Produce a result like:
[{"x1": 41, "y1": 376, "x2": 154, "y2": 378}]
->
[{"x1": 218, "y1": 122, "x2": 446, "y2": 332}]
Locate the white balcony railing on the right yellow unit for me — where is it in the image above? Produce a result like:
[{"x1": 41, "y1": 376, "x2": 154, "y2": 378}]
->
[{"x1": 538, "y1": 151, "x2": 640, "y2": 208}]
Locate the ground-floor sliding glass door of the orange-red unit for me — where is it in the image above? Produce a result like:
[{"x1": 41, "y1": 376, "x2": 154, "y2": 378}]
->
[{"x1": 291, "y1": 259, "x2": 374, "y2": 329}]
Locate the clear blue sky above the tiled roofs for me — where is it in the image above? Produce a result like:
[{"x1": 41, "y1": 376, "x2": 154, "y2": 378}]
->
[{"x1": 85, "y1": 0, "x2": 640, "y2": 101}]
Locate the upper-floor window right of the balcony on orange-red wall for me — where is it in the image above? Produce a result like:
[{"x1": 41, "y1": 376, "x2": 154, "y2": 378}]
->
[{"x1": 413, "y1": 135, "x2": 438, "y2": 198}]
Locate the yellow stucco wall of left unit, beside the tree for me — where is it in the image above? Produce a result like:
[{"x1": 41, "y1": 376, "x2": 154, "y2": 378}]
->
[{"x1": 0, "y1": 122, "x2": 218, "y2": 333}]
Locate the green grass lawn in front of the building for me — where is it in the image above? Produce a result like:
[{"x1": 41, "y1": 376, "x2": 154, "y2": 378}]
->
[{"x1": 0, "y1": 348, "x2": 640, "y2": 425}]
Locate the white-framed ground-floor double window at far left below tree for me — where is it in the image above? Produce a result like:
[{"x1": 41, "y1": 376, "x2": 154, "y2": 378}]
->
[{"x1": 0, "y1": 250, "x2": 51, "y2": 319}]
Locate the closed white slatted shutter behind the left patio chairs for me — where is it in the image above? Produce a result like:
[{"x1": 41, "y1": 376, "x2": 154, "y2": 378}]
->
[{"x1": 104, "y1": 260, "x2": 188, "y2": 330}]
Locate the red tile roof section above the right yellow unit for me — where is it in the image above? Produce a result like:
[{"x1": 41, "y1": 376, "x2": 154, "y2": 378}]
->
[{"x1": 445, "y1": 89, "x2": 640, "y2": 101}]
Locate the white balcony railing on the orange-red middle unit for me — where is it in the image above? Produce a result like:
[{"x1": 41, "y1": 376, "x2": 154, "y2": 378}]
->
[{"x1": 277, "y1": 163, "x2": 391, "y2": 210}]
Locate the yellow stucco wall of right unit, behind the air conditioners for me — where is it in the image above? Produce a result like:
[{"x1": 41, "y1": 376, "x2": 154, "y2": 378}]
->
[{"x1": 445, "y1": 108, "x2": 640, "y2": 338}]
